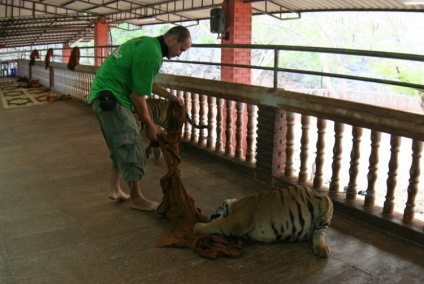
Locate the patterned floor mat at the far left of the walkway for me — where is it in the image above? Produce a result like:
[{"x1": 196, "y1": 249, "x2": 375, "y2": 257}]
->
[{"x1": 0, "y1": 82, "x2": 50, "y2": 108}]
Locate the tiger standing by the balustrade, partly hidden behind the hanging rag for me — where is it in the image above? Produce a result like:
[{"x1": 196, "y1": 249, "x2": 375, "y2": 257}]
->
[{"x1": 137, "y1": 98, "x2": 208, "y2": 159}]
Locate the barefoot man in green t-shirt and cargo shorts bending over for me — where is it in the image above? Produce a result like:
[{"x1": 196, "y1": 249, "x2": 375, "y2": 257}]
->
[{"x1": 88, "y1": 26, "x2": 191, "y2": 211}]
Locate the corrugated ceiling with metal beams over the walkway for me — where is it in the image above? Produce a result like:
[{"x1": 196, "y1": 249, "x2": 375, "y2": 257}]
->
[{"x1": 0, "y1": 0, "x2": 424, "y2": 48}]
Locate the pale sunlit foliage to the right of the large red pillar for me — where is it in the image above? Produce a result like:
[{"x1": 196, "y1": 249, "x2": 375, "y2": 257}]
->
[{"x1": 252, "y1": 12, "x2": 424, "y2": 95}]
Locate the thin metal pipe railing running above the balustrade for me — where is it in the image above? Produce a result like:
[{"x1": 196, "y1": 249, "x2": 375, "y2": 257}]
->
[{"x1": 0, "y1": 44, "x2": 424, "y2": 89}]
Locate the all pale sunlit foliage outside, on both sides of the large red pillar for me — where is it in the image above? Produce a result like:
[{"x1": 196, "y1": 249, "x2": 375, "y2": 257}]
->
[{"x1": 78, "y1": 12, "x2": 424, "y2": 95}]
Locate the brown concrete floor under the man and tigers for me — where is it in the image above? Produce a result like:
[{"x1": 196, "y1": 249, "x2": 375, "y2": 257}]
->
[{"x1": 0, "y1": 96, "x2": 424, "y2": 284}]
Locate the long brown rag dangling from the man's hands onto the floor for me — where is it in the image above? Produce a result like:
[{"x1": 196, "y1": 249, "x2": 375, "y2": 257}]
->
[{"x1": 157, "y1": 101, "x2": 242, "y2": 259}]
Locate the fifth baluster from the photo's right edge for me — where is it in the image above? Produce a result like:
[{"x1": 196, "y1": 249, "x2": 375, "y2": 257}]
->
[{"x1": 330, "y1": 122, "x2": 344, "y2": 193}]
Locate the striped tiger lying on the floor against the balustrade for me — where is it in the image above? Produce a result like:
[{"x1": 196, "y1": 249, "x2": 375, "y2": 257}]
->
[{"x1": 193, "y1": 186, "x2": 333, "y2": 258}]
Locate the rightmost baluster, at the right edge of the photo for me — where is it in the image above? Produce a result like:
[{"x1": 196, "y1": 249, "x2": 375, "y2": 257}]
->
[{"x1": 403, "y1": 140, "x2": 423, "y2": 223}]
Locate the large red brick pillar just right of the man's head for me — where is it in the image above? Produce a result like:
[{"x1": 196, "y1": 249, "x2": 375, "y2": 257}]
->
[{"x1": 221, "y1": 0, "x2": 252, "y2": 155}]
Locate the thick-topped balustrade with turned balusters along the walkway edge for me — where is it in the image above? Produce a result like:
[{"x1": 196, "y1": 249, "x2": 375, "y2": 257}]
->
[{"x1": 14, "y1": 42, "x2": 424, "y2": 246}]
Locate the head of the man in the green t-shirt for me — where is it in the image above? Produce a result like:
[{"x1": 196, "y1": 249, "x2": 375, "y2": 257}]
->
[{"x1": 163, "y1": 26, "x2": 191, "y2": 59}]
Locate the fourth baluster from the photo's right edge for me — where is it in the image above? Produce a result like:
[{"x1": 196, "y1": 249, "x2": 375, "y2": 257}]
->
[{"x1": 346, "y1": 126, "x2": 362, "y2": 201}]
